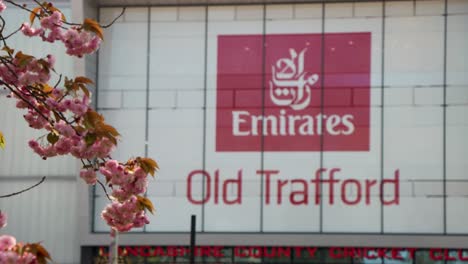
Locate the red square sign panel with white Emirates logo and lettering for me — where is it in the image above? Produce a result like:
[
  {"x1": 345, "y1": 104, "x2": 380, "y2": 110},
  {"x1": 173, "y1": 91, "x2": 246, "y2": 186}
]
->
[{"x1": 216, "y1": 33, "x2": 371, "y2": 151}]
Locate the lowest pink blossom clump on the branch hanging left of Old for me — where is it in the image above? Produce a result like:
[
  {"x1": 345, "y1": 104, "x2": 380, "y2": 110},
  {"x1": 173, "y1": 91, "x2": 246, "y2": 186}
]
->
[{"x1": 101, "y1": 195, "x2": 149, "y2": 232}]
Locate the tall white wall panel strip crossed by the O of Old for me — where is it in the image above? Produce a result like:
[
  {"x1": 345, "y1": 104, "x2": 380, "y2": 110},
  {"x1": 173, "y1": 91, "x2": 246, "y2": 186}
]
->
[{"x1": 146, "y1": 7, "x2": 206, "y2": 232}]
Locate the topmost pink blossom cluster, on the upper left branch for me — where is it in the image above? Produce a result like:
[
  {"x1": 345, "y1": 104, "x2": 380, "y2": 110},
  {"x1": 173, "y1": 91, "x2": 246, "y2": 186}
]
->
[{"x1": 21, "y1": 11, "x2": 101, "y2": 58}]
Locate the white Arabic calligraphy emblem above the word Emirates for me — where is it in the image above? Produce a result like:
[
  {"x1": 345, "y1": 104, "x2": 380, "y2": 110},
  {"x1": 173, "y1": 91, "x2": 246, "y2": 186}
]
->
[{"x1": 270, "y1": 48, "x2": 319, "y2": 110}]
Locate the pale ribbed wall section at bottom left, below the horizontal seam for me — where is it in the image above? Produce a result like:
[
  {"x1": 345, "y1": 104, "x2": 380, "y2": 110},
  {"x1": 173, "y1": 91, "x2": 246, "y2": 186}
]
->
[{"x1": 0, "y1": 177, "x2": 78, "y2": 264}]
